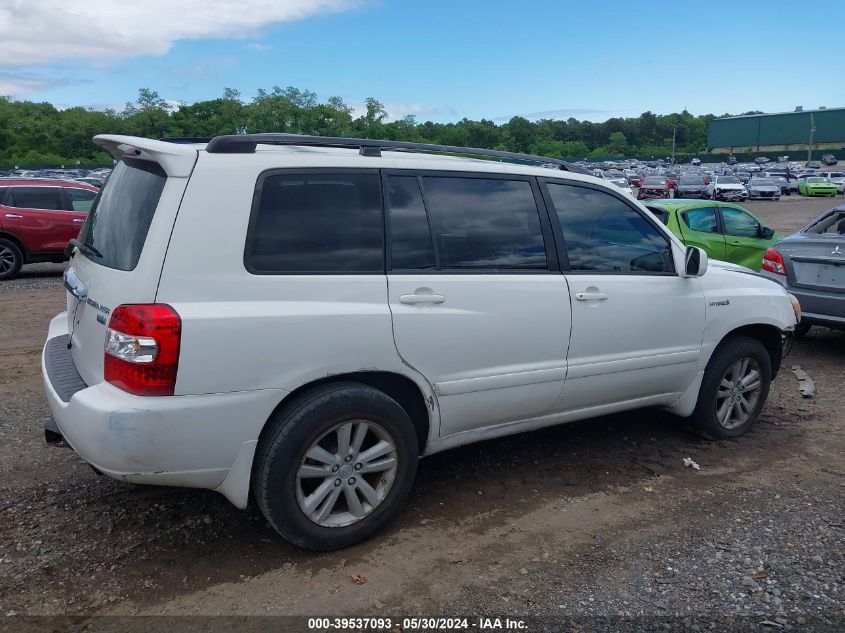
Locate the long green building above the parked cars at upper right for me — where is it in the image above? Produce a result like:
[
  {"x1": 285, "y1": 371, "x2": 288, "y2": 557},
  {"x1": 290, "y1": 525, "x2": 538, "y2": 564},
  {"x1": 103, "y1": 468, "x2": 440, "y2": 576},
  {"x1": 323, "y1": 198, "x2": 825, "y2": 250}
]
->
[{"x1": 707, "y1": 108, "x2": 845, "y2": 154}]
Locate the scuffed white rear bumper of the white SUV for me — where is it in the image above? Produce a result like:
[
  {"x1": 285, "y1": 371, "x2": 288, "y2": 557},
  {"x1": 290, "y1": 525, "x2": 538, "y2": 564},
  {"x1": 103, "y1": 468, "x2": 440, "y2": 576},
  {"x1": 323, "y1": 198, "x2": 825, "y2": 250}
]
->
[{"x1": 41, "y1": 314, "x2": 286, "y2": 506}]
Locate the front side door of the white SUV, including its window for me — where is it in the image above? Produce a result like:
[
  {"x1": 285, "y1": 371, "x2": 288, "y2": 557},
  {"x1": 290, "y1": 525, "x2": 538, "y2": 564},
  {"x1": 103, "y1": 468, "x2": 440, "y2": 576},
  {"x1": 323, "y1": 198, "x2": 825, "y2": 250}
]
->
[{"x1": 544, "y1": 179, "x2": 705, "y2": 411}]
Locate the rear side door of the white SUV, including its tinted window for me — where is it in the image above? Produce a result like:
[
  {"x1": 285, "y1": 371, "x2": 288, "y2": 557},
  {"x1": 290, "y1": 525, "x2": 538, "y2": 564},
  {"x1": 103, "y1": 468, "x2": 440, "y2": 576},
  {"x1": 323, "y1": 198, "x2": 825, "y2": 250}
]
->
[{"x1": 384, "y1": 171, "x2": 570, "y2": 436}]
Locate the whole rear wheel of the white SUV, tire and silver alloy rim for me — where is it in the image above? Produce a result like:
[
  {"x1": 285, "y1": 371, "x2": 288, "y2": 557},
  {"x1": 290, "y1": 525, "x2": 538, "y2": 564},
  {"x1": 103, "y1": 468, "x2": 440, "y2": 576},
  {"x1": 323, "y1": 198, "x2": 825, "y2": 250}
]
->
[{"x1": 253, "y1": 382, "x2": 418, "y2": 551}]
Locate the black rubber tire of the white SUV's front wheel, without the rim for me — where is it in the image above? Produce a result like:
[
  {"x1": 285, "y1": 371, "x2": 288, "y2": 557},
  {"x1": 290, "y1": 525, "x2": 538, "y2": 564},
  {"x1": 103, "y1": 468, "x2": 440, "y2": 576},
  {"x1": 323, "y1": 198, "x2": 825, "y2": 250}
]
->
[{"x1": 690, "y1": 336, "x2": 772, "y2": 440}]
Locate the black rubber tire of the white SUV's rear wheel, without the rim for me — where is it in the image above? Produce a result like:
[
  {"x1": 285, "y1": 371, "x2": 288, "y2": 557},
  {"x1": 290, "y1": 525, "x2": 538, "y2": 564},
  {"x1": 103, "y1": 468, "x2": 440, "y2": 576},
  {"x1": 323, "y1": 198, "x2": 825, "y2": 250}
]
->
[{"x1": 252, "y1": 382, "x2": 419, "y2": 551}]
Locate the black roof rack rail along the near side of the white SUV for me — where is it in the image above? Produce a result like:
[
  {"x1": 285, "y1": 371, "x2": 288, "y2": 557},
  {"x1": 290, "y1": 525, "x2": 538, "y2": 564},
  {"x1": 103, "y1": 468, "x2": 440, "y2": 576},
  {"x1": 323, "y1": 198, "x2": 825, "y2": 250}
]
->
[{"x1": 204, "y1": 133, "x2": 587, "y2": 174}]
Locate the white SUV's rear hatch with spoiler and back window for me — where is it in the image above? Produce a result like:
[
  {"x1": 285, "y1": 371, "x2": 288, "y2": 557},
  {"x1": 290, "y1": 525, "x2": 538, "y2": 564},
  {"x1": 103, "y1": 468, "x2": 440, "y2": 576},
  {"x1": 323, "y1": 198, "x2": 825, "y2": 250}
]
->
[{"x1": 65, "y1": 136, "x2": 197, "y2": 385}]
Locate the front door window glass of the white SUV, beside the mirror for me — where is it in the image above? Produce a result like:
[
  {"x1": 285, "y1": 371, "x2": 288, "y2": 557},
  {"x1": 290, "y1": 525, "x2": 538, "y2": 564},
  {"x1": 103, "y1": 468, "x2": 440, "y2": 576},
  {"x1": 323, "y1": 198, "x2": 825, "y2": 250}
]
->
[{"x1": 547, "y1": 183, "x2": 675, "y2": 273}]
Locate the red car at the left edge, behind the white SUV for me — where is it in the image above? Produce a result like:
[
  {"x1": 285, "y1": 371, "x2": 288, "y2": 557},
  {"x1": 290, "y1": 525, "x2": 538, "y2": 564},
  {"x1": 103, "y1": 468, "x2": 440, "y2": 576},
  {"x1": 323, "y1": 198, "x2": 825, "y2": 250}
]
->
[{"x1": 0, "y1": 178, "x2": 99, "y2": 280}]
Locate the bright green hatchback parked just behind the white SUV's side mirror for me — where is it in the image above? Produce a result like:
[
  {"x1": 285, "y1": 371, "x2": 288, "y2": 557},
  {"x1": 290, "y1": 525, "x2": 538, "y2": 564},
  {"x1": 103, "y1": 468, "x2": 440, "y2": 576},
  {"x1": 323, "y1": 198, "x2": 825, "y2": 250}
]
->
[{"x1": 646, "y1": 198, "x2": 783, "y2": 271}]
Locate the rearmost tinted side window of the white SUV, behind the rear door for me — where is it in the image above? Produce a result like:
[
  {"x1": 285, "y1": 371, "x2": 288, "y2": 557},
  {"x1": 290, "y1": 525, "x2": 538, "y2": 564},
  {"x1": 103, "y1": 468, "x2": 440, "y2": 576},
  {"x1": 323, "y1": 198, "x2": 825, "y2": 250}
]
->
[{"x1": 244, "y1": 172, "x2": 384, "y2": 274}]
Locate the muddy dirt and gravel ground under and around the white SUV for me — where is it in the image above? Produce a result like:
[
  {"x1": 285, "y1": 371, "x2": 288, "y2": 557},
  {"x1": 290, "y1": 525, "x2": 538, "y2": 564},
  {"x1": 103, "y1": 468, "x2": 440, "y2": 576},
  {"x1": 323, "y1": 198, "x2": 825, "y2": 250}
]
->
[{"x1": 0, "y1": 197, "x2": 845, "y2": 631}]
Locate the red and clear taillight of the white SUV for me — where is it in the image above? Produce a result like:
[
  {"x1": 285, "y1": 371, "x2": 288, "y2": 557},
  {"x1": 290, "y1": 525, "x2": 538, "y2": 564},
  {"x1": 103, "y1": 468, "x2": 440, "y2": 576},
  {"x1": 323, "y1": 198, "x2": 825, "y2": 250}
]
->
[{"x1": 103, "y1": 304, "x2": 182, "y2": 396}]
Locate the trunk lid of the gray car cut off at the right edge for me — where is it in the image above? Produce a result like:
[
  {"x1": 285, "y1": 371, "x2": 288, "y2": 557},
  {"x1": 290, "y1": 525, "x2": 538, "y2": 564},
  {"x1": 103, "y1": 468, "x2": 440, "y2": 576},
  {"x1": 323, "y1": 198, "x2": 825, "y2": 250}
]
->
[{"x1": 779, "y1": 234, "x2": 845, "y2": 292}]
